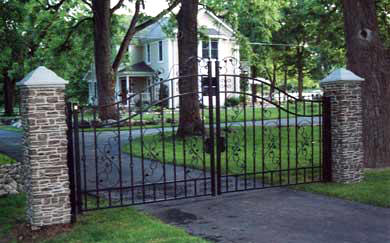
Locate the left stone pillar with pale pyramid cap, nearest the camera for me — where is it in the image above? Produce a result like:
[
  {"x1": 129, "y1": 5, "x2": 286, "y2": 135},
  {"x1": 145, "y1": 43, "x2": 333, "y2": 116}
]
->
[{"x1": 17, "y1": 67, "x2": 71, "y2": 229}]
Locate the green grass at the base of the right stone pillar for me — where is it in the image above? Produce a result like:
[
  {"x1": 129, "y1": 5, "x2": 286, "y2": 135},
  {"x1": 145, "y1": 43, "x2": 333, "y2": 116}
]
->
[{"x1": 293, "y1": 168, "x2": 390, "y2": 208}]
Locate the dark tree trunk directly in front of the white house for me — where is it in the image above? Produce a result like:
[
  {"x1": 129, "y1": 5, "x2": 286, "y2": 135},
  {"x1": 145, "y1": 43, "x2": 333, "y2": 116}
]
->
[{"x1": 177, "y1": 0, "x2": 203, "y2": 137}]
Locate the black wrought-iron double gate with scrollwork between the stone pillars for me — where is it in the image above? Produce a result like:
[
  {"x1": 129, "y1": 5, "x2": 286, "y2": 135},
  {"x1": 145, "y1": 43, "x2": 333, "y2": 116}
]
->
[{"x1": 67, "y1": 59, "x2": 330, "y2": 217}]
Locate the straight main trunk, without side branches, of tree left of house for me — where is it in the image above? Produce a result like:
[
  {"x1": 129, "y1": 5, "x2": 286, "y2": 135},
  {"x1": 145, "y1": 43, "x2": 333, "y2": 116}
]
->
[{"x1": 92, "y1": 0, "x2": 116, "y2": 120}]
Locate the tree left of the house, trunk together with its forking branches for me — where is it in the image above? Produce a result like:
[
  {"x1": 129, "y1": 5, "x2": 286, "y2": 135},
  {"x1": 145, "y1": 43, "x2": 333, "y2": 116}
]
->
[{"x1": 83, "y1": 0, "x2": 180, "y2": 120}]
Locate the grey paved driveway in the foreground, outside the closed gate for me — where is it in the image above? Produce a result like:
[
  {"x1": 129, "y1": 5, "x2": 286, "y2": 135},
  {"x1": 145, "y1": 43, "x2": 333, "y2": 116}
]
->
[{"x1": 137, "y1": 188, "x2": 390, "y2": 243}]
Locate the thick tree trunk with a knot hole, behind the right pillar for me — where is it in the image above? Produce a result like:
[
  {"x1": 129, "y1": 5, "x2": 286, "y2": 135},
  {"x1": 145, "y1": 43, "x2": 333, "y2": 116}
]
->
[{"x1": 343, "y1": 0, "x2": 390, "y2": 167}]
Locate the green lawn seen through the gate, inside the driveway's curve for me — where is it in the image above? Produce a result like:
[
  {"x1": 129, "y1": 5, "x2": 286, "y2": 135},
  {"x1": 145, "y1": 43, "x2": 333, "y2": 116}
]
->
[{"x1": 123, "y1": 126, "x2": 321, "y2": 183}]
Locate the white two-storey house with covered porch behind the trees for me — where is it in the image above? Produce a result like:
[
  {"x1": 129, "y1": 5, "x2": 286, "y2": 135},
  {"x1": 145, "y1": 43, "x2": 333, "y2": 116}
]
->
[{"x1": 85, "y1": 8, "x2": 240, "y2": 107}]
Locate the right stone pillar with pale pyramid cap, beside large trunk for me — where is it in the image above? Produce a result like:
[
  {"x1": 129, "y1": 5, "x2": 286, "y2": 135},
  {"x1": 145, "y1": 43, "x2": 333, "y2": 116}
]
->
[{"x1": 320, "y1": 68, "x2": 364, "y2": 183}]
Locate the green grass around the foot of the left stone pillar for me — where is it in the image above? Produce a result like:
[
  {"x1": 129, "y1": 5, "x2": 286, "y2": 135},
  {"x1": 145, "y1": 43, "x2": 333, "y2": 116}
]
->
[{"x1": 0, "y1": 195, "x2": 208, "y2": 243}]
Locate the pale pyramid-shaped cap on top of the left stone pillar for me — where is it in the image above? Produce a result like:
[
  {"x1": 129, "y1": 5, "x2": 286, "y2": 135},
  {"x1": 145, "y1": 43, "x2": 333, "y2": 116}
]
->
[{"x1": 16, "y1": 66, "x2": 68, "y2": 87}]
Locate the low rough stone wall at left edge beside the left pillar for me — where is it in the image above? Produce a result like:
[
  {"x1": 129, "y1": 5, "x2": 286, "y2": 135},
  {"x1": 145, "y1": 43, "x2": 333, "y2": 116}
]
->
[{"x1": 0, "y1": 163, "x2": 24, "y2": 197}]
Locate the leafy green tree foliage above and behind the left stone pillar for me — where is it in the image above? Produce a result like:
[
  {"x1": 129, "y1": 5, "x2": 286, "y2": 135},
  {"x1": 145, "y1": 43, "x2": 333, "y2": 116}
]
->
[{"x1": 0, "y1": 0, "x2": 91, "y2": 115}]
